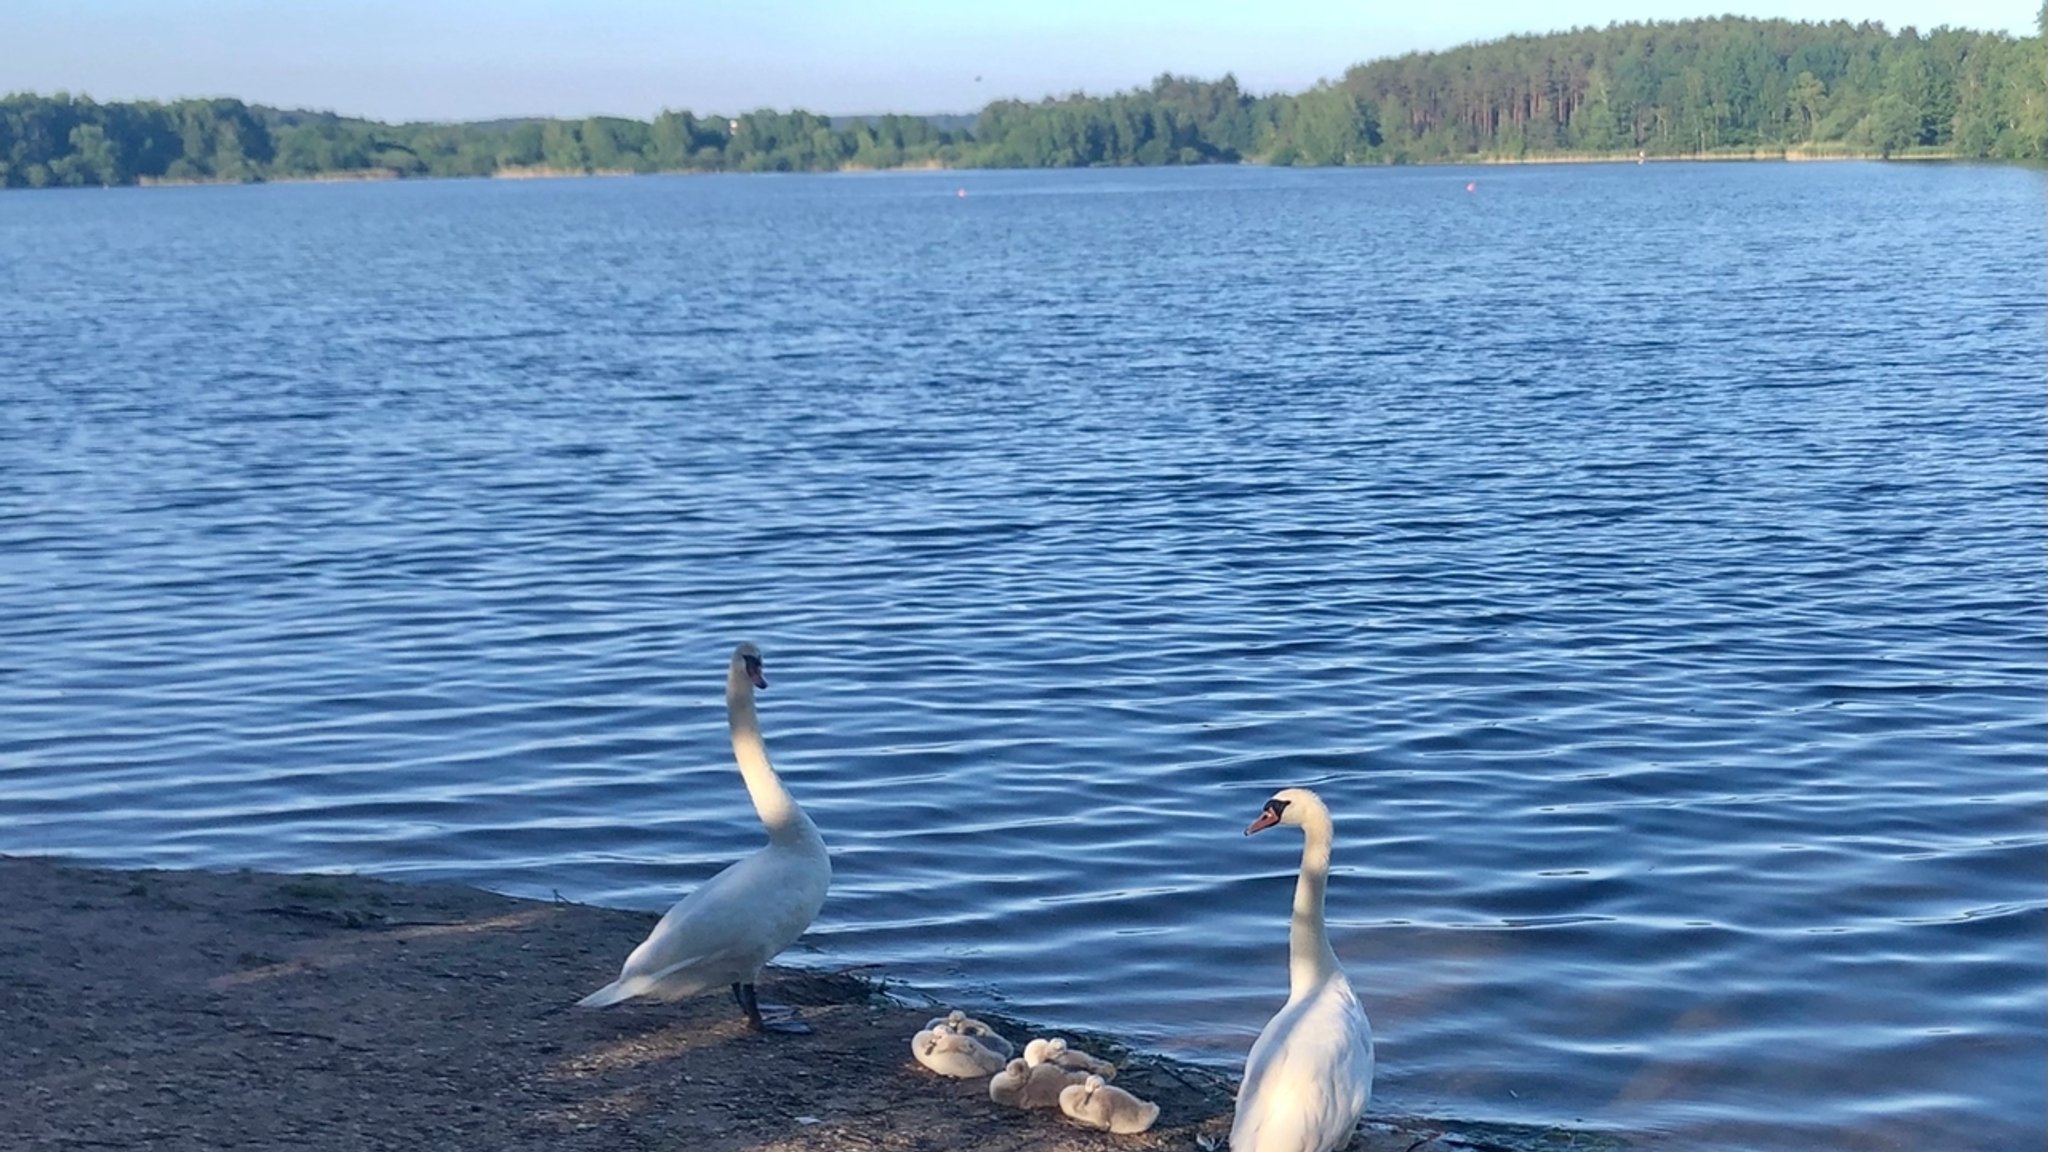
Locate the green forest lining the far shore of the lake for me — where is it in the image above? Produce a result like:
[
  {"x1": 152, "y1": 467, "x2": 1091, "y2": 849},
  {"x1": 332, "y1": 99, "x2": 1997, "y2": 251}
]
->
[{"x1": 0, "y1": 11, "x2": 2048, "y2": 189}]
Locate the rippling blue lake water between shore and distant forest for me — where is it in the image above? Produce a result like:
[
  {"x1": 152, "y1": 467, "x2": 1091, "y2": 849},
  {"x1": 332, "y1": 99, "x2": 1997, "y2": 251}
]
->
[{"x1": 0, "y1": 164, "x2": 2048, "y2": 1152}]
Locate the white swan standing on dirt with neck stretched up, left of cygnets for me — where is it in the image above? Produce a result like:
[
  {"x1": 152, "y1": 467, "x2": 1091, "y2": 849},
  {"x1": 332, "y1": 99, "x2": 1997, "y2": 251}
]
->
[{"x1": 578, "y1": 644, "x2": 831, "y2": 1033}]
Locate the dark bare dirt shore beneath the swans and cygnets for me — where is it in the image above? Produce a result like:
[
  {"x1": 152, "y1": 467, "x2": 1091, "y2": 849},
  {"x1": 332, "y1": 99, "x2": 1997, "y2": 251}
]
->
[{"x1": 0, "y1": 857, "x2": 1540, "y2": 1152}]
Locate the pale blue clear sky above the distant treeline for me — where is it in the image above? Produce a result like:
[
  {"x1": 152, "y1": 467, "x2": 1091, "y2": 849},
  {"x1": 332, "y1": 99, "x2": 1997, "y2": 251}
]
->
[{"x1": 0, "y1": 0, "x2": 2040, "y2": 121}]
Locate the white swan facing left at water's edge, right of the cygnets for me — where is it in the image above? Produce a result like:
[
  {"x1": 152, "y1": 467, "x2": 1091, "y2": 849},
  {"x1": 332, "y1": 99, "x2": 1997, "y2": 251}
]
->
[{"x1": 1231, "y1": 787, "x2": 1372, "y2": 1152}]
